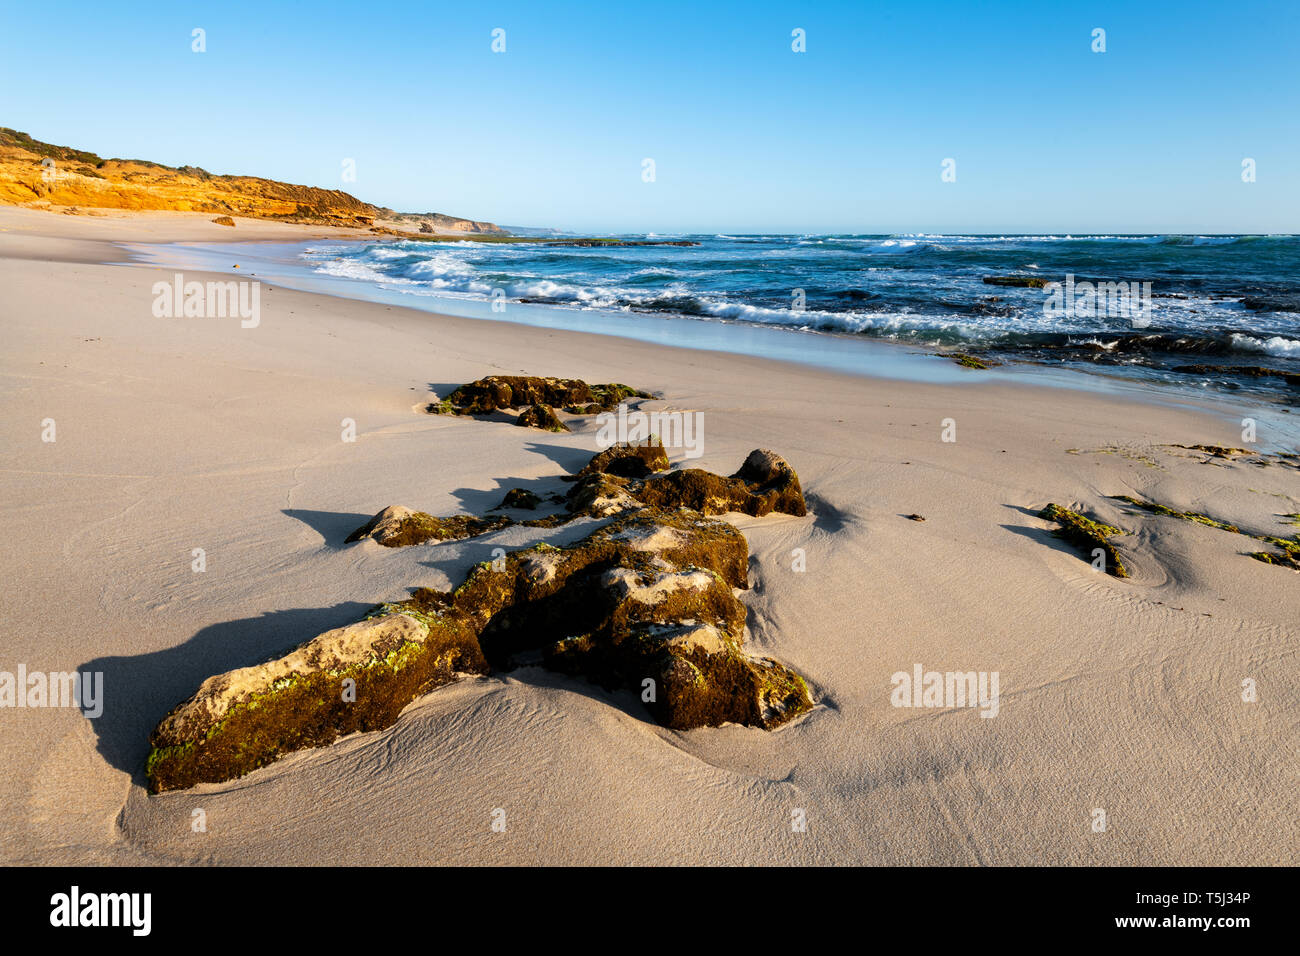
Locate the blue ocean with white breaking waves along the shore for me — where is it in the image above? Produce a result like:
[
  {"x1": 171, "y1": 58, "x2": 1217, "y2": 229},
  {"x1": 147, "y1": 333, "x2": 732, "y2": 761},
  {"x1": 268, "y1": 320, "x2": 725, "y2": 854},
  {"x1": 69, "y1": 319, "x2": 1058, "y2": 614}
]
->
[{"x1": 300, "y1": 234, "x2": 1300, "y2": 403}]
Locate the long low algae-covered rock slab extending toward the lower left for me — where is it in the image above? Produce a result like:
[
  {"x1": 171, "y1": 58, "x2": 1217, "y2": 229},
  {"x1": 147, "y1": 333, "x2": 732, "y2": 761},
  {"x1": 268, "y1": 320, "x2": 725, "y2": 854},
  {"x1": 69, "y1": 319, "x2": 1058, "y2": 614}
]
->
[{"x1": 146, "y1": 614, "x2": 488, "y2": 793}]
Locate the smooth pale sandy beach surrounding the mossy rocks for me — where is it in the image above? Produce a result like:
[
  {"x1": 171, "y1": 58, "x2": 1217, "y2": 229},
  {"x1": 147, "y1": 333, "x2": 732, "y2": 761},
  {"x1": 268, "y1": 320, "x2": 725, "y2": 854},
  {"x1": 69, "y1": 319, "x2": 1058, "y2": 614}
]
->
[{"x1": 0, "y1": 208, "x2": 1300, "y2": 866}]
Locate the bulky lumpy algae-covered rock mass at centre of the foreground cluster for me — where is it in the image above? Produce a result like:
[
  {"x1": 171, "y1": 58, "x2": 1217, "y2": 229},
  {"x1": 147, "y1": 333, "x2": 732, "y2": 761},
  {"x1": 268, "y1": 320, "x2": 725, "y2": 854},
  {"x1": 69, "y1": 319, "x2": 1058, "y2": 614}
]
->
[{"x1": 449, "y1": 509, "x2": 811, "y2": 730}]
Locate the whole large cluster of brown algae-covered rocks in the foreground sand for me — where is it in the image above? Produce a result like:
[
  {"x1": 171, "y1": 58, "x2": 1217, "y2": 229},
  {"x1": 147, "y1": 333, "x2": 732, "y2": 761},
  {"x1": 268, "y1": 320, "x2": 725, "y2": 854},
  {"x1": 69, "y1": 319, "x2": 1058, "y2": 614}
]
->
[{"x1": 146, "y1": 442, "x2": 813, "y2": 792}]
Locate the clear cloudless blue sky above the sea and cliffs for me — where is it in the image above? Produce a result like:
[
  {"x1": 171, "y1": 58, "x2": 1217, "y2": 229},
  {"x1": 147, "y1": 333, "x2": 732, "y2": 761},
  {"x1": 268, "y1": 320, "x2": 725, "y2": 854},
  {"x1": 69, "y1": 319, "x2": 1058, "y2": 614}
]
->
[{"x1": 0, "y1": 0, "x2": 1300, "y2": 233}]
